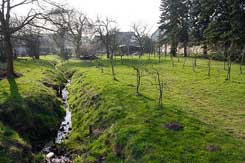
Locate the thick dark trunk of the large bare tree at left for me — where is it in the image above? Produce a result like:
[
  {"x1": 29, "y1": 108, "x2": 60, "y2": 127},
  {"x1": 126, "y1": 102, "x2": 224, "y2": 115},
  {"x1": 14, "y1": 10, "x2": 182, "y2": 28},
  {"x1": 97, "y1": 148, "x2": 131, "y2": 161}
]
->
[{"x1": 4, "y1": 34, "x2": 15, "y2": 78}]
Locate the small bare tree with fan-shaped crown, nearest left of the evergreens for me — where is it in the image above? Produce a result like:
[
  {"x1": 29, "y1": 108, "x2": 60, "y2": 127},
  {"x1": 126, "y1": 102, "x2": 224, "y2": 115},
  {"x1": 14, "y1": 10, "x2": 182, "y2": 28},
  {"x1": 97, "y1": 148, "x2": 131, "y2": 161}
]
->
[{"x1": 132, "y1": 24, "x2": 147, "y2": 57}]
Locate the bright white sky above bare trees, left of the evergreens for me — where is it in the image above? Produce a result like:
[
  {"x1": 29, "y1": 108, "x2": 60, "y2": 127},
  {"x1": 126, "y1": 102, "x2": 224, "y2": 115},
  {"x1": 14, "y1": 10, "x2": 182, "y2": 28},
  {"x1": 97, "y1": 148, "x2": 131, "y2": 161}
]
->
[{"x1": 66, "y1": 0, "x2": 160, "y2": 32}]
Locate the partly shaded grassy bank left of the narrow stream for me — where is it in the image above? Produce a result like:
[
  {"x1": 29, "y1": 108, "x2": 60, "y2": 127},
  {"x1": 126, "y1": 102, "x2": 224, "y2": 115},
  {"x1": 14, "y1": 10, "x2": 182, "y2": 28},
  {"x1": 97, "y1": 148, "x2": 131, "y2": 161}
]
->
[{"x1": 0, "y1": 59, "x2": 64, "y2": 162}]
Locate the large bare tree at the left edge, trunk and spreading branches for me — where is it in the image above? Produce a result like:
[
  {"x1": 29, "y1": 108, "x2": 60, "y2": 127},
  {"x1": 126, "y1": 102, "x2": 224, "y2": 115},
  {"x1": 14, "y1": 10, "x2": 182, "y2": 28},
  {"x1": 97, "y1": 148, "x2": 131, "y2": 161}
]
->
[{"x1": 0, "y1": 0, "x2": 41, "y2": 77}]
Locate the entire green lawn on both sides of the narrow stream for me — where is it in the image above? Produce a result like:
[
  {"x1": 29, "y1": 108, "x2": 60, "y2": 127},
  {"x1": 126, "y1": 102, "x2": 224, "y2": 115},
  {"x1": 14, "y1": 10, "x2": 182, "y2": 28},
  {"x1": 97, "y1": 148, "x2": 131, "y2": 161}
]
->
[{"x1": 0, "y1": 56, "x2": 245, "y2": 163}]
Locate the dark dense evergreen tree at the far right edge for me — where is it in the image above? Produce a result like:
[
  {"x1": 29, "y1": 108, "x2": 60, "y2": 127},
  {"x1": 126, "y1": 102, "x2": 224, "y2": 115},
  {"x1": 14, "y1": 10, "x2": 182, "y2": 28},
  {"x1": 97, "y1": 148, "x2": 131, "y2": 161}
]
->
[{"x1": 204, "y1": 0, "x2": 245, "y2": 51}]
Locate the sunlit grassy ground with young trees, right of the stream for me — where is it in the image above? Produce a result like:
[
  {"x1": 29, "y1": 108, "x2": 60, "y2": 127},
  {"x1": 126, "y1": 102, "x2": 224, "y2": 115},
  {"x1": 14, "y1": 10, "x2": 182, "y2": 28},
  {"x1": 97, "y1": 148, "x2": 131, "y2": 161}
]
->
[{"x1": 63, "y1": 55, "x2": 245, "y2": 163}]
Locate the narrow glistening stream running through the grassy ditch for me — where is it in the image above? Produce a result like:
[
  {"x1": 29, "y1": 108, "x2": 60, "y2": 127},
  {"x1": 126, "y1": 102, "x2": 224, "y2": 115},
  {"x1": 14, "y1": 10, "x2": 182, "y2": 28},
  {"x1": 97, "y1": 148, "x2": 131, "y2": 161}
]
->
[{"x1": 42, "y1": 80, "x2": 72, "y2": 163}]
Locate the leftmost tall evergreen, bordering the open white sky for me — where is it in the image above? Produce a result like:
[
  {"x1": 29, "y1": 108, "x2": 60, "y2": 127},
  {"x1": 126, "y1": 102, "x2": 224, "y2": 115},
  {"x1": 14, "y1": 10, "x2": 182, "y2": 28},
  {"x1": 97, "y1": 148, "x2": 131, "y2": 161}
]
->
[{"x1": 160, "y1": 0, "x2": 190, "y2": 56}]
